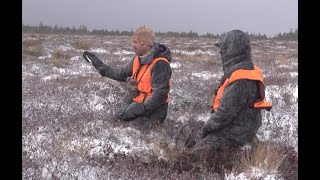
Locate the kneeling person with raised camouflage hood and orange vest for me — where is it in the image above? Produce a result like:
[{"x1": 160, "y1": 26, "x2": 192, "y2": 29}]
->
[{"x1": 202, "y1": 30, "x2": 272, "y2": 149}]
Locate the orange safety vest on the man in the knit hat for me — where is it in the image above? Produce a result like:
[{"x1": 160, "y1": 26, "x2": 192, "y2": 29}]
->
[{"x1": 132, "y1": 56, "x2": 170, "y2": 103}]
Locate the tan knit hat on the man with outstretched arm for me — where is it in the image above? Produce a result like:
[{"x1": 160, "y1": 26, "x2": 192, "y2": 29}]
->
[{"x1": 133, "y1": 26, "x2": 156, "y2": 46}]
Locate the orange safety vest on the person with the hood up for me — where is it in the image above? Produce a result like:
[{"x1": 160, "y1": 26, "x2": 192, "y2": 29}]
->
[{"x1": 212, "y1": 66, "x2": 272, "y2": 111}]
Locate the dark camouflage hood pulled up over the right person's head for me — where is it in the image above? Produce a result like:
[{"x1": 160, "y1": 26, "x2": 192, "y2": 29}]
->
[{"x1": 215, "y1": 30, "x2": 253, "y2": 74}]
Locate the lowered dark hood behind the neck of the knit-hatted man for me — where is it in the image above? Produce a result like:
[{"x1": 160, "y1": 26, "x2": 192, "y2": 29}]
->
[{"x1": 141, "y1": 43, "x2": 172, "y2": 64}]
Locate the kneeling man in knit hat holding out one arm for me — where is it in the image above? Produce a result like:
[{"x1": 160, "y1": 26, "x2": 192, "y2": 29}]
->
[{"x1": 83, "y1": 27, "x2": 172, "y2": 126}]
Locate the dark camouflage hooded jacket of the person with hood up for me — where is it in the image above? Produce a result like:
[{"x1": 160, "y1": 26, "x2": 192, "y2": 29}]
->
[{"x1": 203, "y1": 30, "x2": 262, "y2": 148}]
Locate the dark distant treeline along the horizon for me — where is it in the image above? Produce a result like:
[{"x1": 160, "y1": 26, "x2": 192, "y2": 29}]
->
[{"x1": 22, "y1": 22, "x2": 298, "y2": 40}]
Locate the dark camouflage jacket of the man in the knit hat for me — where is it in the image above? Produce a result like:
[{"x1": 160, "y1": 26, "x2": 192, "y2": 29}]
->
[{"x1": 100, "y1": 43, "x2": 172, "y2": 121}]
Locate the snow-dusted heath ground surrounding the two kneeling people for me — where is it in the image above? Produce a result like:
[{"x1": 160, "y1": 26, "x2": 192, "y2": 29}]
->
[{"x1": 22, "y1": 34, "x2": 298, "y2": 180}]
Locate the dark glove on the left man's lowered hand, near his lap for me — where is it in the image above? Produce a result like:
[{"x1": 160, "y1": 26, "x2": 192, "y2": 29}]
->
[{"x1": 120, "y1": 102, "x2": 146, "y2": 121}]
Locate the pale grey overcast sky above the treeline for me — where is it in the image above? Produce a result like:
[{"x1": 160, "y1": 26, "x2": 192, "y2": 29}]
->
[{"x1": 22, "y1": 0, "x2": 298, "y2": 36}]
